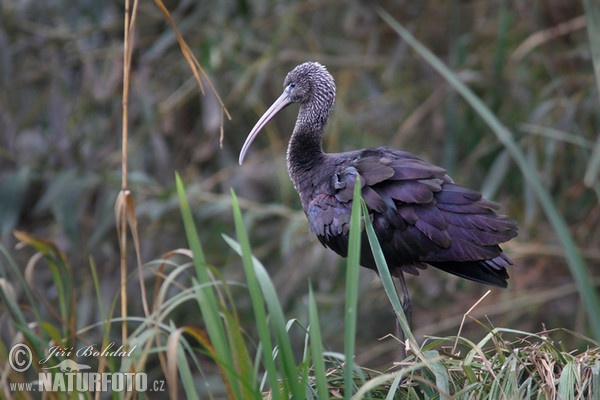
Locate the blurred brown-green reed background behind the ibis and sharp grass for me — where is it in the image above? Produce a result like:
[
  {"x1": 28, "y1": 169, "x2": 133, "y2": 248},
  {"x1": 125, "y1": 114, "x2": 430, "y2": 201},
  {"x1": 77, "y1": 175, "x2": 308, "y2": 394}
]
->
[{"x1": 0, "y1": 0, "x2": 600, "y2": 366}]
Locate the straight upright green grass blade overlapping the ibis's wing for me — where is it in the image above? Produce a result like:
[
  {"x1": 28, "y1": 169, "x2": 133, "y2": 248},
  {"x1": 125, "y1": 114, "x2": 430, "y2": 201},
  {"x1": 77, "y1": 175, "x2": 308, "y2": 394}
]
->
[{"x1": 344, "y1": 178, "x2": 368, "y2": 399}]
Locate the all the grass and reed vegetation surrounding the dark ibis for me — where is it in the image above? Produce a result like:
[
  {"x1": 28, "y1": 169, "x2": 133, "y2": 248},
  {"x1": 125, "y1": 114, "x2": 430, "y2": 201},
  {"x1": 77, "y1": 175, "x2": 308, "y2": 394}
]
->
[{"x1": 0, "y1": 0, "x2": 600, "y2": 399}]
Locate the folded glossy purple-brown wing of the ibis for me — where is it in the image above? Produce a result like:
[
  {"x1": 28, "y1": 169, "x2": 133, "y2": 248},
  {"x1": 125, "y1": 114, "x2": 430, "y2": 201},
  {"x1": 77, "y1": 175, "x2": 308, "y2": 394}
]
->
[{"x1": 307, "y1": 148, "x2": 516, "y2": 278}]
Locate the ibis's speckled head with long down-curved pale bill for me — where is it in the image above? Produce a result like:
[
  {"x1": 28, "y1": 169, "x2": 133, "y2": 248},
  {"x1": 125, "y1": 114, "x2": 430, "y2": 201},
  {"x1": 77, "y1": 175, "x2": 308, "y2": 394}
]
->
[{"x1": 239, "y1": 62, "x2": 335, "y2": 165}]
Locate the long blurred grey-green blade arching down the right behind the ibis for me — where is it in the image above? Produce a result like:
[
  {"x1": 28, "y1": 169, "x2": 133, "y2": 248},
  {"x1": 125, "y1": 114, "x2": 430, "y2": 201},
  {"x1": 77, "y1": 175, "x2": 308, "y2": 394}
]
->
[{"x1": 377, "y1": 8, "x2": 600, "y2": 339}]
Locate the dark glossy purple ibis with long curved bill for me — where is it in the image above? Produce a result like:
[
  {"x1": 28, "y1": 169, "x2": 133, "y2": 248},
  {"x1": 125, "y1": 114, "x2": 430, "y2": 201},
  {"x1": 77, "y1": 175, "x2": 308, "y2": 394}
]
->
[{"x1": 239, "y1": 62, "x2": 518, "y2": 332}]
